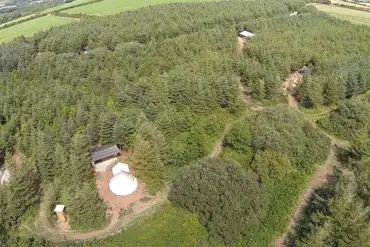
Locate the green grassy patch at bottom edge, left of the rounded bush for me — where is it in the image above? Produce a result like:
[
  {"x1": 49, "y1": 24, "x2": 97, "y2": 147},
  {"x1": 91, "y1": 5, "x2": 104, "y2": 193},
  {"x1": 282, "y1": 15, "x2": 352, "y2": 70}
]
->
[{"x1": 61, "y1": 203, "x2": 214, "y2": 247}]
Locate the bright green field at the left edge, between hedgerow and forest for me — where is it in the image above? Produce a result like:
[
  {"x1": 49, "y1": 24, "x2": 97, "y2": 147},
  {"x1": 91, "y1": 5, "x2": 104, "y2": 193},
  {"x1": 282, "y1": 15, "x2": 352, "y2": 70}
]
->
[{"x1": 0, "y1": 16, "x2": 76, "y2": 43}]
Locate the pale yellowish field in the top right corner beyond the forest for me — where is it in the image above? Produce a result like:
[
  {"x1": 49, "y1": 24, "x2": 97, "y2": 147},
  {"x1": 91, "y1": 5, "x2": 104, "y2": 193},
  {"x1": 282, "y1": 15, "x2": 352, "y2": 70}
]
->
[{"x1": 314, "y1": 4, "x2": 370, "y2": 26}]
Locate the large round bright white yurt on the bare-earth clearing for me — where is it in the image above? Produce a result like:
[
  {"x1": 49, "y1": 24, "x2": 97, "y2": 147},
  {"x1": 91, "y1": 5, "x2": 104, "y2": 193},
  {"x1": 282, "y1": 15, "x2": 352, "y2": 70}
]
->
[{"x1": 109, "y1": 172, "x2": 138, "y2": 196}]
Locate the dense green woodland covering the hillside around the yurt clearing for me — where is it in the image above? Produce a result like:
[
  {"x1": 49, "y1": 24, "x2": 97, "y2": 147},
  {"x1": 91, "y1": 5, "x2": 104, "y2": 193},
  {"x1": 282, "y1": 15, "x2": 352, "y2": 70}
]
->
[{"x1": 0, "y1": 0, "x2": 370, "y2": 247}]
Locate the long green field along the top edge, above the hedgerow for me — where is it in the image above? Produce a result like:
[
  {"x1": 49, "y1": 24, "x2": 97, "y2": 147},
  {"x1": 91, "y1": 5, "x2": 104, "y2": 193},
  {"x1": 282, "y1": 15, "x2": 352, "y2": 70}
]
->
[{"x1": 63, "y1": 0, "x2": 214, "y2": 15}]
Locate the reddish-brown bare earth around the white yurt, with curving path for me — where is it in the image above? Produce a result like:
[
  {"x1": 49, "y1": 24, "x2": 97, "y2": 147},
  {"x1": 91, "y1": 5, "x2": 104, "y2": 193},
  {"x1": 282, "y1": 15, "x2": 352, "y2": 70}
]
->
[{"x1": 37, "y1": 152, "x2": 168, "y2": 242}]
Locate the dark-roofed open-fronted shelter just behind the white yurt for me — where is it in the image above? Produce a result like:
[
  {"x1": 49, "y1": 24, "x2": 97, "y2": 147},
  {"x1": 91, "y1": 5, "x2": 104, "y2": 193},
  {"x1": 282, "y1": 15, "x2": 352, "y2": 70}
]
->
[{"x1": 91, "y1": 144, "x2": 121, "y2": 172}]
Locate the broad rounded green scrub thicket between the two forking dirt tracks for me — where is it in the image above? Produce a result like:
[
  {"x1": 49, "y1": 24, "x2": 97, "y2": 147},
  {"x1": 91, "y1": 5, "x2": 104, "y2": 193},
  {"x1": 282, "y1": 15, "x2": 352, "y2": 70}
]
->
[{"x1": 223, "y1": 106, "x2": 330, "y2": 178}]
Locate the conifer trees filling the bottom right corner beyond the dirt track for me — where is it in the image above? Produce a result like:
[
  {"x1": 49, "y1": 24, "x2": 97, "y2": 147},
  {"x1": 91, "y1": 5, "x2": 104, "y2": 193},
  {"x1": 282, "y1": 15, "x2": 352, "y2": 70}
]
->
[{"x1": 288, "y1": 164, "x2": 370, "y2": 247}]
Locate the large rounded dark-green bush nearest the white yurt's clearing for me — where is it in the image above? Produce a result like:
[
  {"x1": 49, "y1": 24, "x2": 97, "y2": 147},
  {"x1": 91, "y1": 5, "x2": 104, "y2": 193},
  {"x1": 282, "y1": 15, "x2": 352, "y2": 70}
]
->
[{"x1": 168, "y1": 158, "x2": 266, "y2": 243}]
